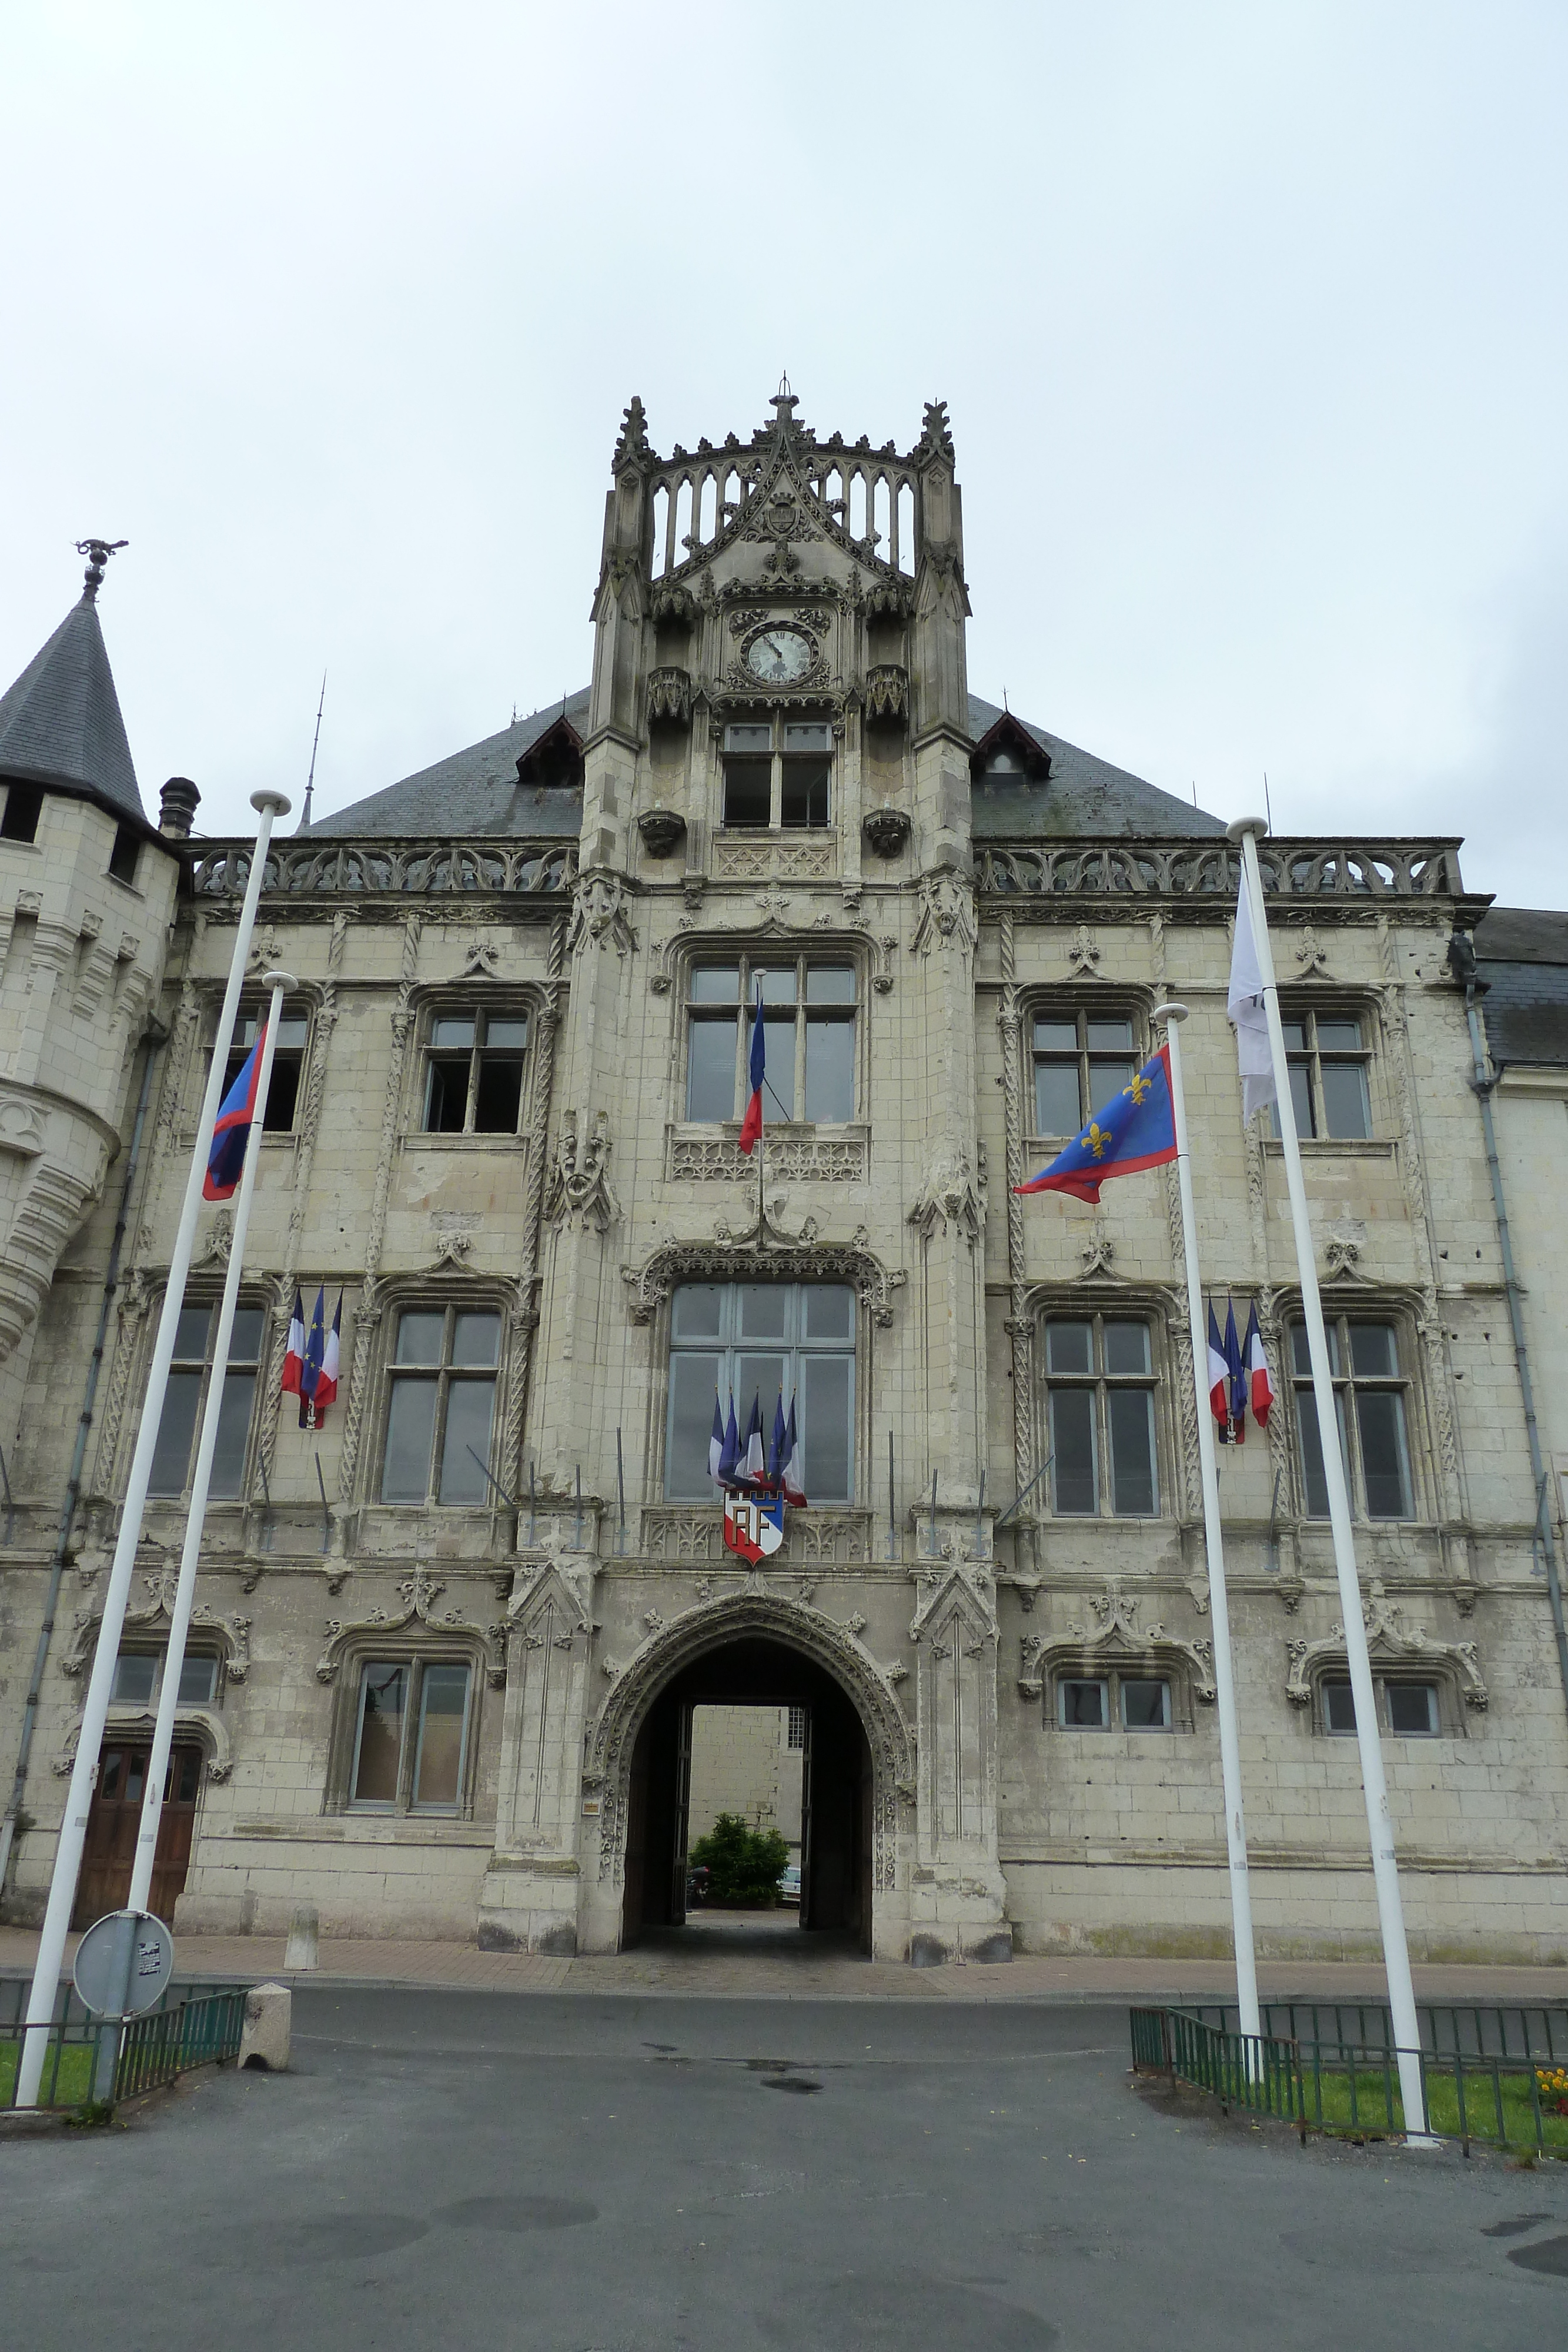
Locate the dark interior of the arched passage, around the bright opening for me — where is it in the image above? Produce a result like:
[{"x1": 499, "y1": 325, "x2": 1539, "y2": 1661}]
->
[{"x1": 621, "y1": 1635, "x2": 872, "y2": 1952}]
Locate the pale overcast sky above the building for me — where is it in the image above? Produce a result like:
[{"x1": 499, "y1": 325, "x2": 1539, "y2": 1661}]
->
[{"x1": 0, "y1": 0, "x2": 1568, "y2": 906}]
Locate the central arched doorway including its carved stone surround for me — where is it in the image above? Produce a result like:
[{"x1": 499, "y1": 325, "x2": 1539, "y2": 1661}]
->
[{"x1": 579, "y1": 1578, "x2": 914, "y2": 1959}]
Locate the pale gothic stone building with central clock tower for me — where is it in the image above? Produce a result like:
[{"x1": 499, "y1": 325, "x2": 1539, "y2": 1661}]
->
[{"x1": 0, "y1": 393, "x2": 1568, "y2": 1962}]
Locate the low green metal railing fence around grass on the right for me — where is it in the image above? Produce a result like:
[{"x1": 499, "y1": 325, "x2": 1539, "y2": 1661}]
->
[{"x1": 1131, "y1": 2002, "x2": 1568, "y2": 2159}]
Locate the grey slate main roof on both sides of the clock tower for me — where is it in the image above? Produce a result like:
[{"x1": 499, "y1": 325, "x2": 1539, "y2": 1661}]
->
[{"x1": 310, "y1": 687, "x2": 1225, "y2": 840}]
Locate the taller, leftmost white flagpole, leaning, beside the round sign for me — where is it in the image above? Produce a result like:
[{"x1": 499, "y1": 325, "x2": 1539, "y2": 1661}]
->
[{"x1": 16, "y1": 793, "x2": 289, "y2": 2107}]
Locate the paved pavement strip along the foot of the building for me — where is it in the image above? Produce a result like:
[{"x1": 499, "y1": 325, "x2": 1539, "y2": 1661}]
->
[{"x1": 0, "y1": 1912, "x2": 1568, "y2": 2002}]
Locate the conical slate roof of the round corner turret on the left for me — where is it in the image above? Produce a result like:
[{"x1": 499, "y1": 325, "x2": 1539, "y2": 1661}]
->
[{"x1": 0, "y1": 597, "x2": 148, "y2": 826}]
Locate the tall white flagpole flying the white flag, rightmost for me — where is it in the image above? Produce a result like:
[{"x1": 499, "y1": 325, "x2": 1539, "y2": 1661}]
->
[{"x1": 1227, "y1": 816, "x2": 1436, "y2": 2147}]
